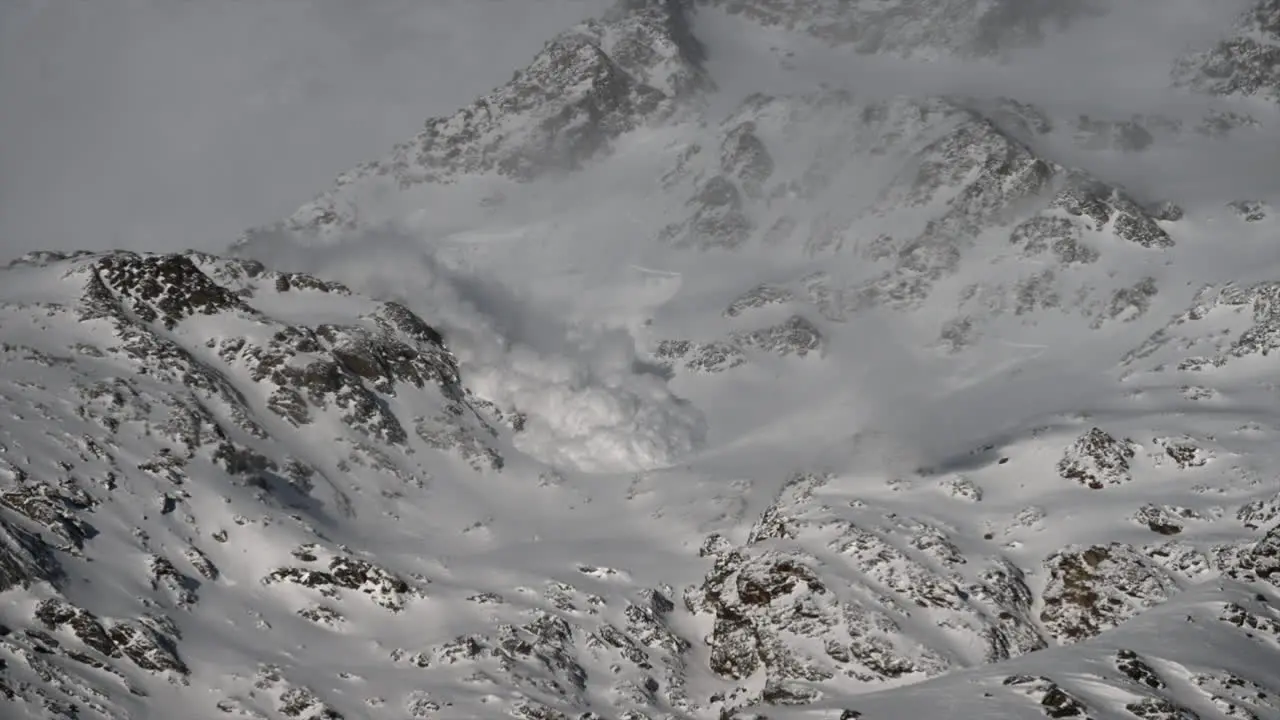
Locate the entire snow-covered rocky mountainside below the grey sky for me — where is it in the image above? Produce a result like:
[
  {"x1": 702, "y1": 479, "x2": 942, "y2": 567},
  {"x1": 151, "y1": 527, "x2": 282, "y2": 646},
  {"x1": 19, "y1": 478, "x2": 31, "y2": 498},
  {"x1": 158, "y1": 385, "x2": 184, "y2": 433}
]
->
[{"x1": 0, "y1": 0, "x2": 1280, "y2": 720}]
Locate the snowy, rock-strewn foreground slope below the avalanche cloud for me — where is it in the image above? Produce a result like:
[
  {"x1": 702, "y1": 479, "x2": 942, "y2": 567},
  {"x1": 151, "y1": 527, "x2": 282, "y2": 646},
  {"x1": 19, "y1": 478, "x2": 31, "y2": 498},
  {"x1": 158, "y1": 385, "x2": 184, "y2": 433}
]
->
[{"x1": 0, "y1": 244, "x2": 1280, "y2": 717}]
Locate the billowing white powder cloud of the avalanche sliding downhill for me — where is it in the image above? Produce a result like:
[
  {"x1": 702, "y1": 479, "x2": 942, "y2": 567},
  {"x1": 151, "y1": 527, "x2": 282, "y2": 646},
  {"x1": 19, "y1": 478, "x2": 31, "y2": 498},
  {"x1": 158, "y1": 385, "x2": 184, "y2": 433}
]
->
[{"x1": 244, "y1": 221, "x2": 707, "y2": 473}]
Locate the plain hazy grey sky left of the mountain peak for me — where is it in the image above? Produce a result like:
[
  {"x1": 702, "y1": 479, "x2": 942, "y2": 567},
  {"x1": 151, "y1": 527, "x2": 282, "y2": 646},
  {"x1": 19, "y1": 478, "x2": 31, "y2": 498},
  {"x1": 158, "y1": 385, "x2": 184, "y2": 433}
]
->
[{"x1": 0, "y1": 0, "x2": 605, "y2": 256}]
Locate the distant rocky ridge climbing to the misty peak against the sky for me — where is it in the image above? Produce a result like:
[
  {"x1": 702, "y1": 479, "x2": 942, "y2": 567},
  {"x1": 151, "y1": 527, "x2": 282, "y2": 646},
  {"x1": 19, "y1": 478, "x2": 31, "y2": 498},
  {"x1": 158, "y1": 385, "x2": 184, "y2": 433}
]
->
[{"x1": 242, "y1": 0, "x2": 712, "y2": 243}]
